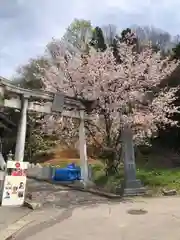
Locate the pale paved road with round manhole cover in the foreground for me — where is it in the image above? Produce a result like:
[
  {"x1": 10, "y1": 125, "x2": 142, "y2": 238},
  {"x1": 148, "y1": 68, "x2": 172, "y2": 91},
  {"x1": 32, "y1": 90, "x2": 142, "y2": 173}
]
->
[{"x1": 15, "y1": 179, "x2": 180, "y2": 240}]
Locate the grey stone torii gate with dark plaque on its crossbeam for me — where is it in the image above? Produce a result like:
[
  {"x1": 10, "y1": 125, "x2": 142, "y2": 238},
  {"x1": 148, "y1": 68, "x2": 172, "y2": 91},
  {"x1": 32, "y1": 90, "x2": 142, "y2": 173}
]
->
[{"x1": 0, "y1": 77, "x2": 93, "y2": 183}]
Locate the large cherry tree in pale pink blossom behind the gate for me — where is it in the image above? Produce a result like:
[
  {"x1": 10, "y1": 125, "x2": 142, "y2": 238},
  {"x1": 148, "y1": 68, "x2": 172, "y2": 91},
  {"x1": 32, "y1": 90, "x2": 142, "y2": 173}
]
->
[{"x1": 35, "y1": 38, "x2": 179, "y2": 172}]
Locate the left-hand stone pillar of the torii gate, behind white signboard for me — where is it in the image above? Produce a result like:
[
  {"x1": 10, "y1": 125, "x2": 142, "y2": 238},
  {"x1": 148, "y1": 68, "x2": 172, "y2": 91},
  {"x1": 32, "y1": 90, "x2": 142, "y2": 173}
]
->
[{"x1": 15, "y1": 98, "x2": 28, "y2": 161}]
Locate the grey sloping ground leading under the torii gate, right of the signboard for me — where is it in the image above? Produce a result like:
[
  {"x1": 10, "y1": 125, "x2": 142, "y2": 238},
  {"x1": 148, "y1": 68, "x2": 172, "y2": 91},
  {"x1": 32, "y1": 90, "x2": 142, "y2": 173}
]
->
[{"x1": 27, "y1": 179, "x2": 115, "y2": 208}]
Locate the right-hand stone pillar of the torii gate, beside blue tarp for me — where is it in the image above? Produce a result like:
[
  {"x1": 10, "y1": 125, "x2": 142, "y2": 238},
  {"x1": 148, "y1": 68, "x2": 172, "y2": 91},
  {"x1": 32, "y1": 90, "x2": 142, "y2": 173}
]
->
[{"x1": 79, "y1": 110, "x2": 89, "y2": 187}]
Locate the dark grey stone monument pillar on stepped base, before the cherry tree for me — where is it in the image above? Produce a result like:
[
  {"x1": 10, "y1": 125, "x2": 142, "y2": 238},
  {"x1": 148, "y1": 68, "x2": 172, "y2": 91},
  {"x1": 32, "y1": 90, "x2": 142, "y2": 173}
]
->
[{"x1": 121, "y1": 127, "x2": 145, "y2": 196}]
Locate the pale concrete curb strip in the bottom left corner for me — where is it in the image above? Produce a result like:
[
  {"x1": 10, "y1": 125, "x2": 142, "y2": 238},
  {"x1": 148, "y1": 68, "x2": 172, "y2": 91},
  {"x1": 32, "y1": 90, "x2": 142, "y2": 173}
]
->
[{"x1": 0, "y1": 213, "x2": 32, "y2": 240}]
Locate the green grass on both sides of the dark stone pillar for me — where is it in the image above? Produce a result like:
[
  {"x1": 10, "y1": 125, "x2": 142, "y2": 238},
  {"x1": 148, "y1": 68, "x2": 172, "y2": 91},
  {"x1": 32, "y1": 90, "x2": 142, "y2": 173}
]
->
[{"x1": 93, "y1": 165, "x2": 180, "y2": 195}]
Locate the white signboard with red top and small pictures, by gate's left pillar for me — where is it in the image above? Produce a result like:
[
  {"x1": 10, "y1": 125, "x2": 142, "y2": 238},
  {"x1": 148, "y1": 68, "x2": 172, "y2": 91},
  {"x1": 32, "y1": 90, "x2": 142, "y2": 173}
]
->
[{"x1": 2, "y1": 161, "x2": 28, "y2": 206}]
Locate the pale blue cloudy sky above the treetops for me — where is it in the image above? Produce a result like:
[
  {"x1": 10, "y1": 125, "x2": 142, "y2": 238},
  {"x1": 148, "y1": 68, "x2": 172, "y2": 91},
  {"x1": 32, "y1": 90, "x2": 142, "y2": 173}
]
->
[{"x1": 0, "y1": 0, "x2": 180, "y2": 78}]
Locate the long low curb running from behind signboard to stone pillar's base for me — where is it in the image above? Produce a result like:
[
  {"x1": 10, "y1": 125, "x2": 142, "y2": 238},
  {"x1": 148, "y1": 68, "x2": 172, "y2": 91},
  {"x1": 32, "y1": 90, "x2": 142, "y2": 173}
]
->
[{"x1": 28, "y1": 177, "x2": 123, "y2": 199}]
